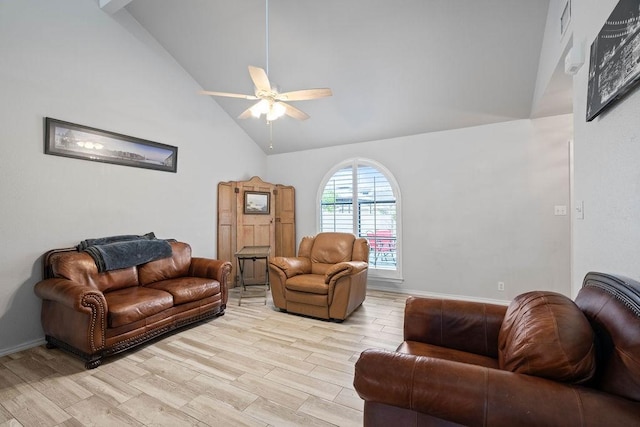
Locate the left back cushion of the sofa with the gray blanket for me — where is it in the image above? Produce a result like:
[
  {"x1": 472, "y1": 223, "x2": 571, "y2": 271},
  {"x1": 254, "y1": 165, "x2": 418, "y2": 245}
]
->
[{"x1": 48, "y1": 251, "x2": 138, "y2": 292}]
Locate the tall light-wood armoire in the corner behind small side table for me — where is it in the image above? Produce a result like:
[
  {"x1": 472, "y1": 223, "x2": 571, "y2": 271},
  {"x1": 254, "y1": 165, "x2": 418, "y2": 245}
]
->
[{"x1": 218, "y1": 176, "x2": 296, "y2": 287}]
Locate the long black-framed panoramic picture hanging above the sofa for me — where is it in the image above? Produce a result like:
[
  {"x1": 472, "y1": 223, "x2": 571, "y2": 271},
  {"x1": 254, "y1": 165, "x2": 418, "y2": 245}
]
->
[{"x1": 44, "y1": 117, "x2": 178, "y2": 172}]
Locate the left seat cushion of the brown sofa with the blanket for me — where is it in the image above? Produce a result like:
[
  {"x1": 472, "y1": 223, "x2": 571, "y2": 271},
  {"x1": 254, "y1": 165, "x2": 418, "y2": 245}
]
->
[{"x1": 104, "y1": 286, "x2": 173, "y2": 328}]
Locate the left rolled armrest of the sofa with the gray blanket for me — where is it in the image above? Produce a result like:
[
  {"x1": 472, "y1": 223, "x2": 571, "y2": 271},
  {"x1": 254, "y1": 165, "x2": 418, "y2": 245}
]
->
[{"x1": 34, "y1": 278, "x2": 107, "y2": 317}]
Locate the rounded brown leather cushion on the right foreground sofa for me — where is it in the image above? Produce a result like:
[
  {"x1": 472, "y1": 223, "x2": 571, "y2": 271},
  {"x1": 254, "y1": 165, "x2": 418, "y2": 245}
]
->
[{"x1": 498, "y1": 291, "x2": 595, "y2": 383}]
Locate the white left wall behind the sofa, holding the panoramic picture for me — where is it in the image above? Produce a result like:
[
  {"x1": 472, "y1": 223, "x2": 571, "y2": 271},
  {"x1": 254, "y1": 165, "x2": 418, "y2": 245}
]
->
[{"x1": 0, "y1": 0, "x2": 266, "y2": 355}]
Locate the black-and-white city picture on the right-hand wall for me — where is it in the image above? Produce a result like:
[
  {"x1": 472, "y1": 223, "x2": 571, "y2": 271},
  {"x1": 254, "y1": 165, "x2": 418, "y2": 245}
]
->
[{"x1": 586, "y1": 0, "x2": 640, "y2": 122}]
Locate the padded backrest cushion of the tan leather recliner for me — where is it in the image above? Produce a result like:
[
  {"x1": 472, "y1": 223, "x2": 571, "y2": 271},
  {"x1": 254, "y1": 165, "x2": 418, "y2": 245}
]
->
[{"x1": 309, "y1": 232, "x2": 356, "y2": 274}]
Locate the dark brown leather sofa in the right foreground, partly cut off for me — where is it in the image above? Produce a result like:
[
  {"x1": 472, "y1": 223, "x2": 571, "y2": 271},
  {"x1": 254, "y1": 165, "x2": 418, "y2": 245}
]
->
[{"x1": 354, "y1": 273, "x2": 640, "y2": 427}]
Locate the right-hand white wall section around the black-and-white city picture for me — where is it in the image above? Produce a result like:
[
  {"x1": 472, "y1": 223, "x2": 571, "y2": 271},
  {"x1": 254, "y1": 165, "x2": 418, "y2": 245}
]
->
[{"x1": 573, "y1": 0, "x2": 640, "y2": 292}]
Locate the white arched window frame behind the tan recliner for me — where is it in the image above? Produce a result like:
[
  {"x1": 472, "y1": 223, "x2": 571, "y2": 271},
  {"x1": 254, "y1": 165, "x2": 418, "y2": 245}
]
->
[{"x1": 316, "y1": 157, "x2": 403, "y2": 283}]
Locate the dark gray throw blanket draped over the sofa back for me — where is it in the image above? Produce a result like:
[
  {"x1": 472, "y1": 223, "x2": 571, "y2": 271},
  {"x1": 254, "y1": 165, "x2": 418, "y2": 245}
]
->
[{"x1": 78, "y1": 233, "x2": 171, "y2": 272}]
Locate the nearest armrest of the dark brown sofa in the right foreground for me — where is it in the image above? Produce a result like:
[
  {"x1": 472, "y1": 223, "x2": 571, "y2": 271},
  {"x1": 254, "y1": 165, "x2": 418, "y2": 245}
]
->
[{"x1": 354, "y1": 350, "x2": 640, "y2": 426}]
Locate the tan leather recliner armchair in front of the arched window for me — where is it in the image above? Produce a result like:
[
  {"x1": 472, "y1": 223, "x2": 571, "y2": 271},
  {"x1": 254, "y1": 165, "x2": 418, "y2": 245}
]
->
[{"x1": 269, "y1": 232, "x2": 369, "y2": 320}]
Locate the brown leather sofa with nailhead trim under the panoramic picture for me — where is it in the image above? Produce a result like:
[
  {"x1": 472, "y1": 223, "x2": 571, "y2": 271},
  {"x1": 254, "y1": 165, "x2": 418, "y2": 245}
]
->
[{"x1": 35, "y1": 241, "x2": 231, "y2": 369}]
